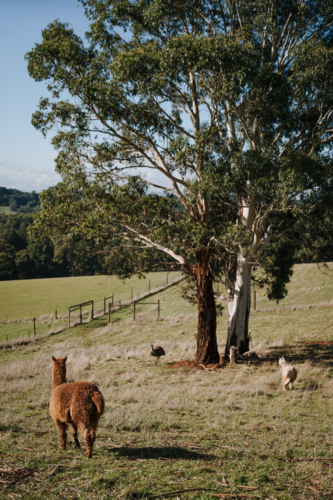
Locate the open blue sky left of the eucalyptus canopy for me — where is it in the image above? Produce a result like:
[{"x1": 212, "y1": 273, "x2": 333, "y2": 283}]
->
[{"x1": 0, "y1": 0, "x2": 88, "y2": 192}]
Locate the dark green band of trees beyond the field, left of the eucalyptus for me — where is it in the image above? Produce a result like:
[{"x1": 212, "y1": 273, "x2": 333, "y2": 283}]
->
[{"x1": 0, "y1": 214, "x2": 171, "y2": 281}]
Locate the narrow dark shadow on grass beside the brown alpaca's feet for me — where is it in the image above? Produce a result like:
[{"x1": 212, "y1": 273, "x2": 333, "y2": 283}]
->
[{"x1": 107, "y1": 446, "x2": 216, "y2": 460}]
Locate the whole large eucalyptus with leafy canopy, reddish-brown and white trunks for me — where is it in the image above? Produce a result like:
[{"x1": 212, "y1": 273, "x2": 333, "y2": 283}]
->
[{"x1": 26, "y1": 0, "x2": 333, "y2": 363}]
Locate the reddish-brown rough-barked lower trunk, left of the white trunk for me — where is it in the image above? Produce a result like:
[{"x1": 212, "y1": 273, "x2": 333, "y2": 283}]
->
[{"x1": 195, "y1": 250, "x2": 220, "y2": 364}]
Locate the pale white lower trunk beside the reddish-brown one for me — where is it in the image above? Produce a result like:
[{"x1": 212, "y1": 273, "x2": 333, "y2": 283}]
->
[{"x1": 225, "y1": 255, "x2": 252, "y2": 358}]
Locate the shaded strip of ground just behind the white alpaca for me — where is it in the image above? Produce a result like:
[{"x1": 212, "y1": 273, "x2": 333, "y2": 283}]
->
[{"x1": 260, "y1": 340, "x2": 333, "y2": 366}]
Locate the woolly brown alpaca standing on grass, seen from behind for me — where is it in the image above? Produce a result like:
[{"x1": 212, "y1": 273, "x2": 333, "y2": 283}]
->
[{"x1": 50, "y1": 356, "x2": 104, "y2": 458}]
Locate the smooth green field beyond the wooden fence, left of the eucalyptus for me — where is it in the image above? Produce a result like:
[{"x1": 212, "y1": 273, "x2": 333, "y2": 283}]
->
[{"x1": 0, "y1": 272, "x2": 179, "y2": 343}]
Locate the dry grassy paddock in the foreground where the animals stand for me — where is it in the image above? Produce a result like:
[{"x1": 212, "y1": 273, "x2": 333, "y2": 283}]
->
[{"x1": 0, "y1": 266, "x2": 333, "y2": 500}]
